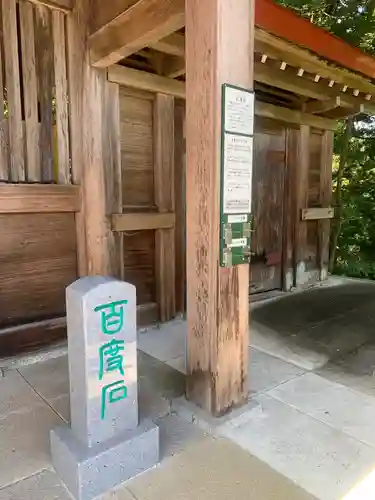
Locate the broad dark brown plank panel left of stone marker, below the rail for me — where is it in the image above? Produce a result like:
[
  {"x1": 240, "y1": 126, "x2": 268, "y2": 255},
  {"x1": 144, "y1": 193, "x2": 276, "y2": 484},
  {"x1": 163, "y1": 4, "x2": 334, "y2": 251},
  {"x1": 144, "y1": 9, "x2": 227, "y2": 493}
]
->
[{"x1": 0, "y1": 214, "x2": 77, "y2": 327}]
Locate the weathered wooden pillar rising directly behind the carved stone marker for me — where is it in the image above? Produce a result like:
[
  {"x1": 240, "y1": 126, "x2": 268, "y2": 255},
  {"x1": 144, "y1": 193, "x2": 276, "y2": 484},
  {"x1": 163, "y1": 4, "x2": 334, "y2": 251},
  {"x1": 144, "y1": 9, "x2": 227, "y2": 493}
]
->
[{"x1": 67, "y1": 0, "x2": 122, "y2": 277}]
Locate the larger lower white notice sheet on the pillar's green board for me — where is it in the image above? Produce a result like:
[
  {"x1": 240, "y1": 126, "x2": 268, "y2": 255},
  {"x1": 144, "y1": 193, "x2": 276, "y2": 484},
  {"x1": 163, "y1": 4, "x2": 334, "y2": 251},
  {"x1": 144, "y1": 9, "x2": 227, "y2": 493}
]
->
[{"x1": 223, "y1": 133, "x2": 253, "y2": 214}]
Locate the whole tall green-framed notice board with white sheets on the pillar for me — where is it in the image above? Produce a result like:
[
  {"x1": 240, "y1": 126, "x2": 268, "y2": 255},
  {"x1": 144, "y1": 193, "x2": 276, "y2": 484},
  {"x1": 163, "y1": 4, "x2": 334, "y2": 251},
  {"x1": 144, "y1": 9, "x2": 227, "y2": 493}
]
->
[{"x1": 220, "y1": 84, "x2": 254, "y2": 267}]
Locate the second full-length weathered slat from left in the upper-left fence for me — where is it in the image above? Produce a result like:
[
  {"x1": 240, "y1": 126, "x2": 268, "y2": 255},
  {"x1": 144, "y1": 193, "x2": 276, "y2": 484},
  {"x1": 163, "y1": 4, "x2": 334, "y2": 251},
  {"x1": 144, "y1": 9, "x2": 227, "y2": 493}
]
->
[{"x1": 19, "y1": 2, "x2": 41, "y2": 181}]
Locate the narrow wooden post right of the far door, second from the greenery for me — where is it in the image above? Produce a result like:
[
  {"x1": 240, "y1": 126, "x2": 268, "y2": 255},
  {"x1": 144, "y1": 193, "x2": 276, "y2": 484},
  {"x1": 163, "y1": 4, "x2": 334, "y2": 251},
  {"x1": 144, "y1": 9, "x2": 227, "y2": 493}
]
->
[{"x1": 295, "y1": 125, "x2": 310, "y2": 287}]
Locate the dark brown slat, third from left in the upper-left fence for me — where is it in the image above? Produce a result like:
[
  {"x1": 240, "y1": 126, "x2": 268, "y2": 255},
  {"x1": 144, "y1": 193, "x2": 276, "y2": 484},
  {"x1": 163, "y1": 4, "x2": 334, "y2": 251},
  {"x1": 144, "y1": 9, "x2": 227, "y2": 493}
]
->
[{"x1": 35, "y1": 5, "x2": 54, "y2": 182}]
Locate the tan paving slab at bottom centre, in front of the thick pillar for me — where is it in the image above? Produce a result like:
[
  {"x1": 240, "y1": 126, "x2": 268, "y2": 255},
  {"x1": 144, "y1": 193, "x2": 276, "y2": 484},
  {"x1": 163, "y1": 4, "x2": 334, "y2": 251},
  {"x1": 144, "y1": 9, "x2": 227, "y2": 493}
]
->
[{"x1": 128, "y1": 437, "x2": 314, "y2": 500}]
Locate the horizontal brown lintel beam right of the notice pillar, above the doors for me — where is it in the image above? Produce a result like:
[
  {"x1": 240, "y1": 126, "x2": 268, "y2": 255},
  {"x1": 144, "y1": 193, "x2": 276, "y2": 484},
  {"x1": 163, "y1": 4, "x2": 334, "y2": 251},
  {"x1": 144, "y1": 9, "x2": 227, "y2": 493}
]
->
[{"x1": 255, "y1": 101, "x2": 336, "y2": 130}]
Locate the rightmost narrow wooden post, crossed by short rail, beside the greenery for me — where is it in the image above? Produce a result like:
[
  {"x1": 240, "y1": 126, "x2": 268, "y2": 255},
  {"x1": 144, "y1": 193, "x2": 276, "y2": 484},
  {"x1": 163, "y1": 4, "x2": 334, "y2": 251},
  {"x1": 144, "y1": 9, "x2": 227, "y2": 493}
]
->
[{"x1": 318, "y1": 130, "x2": 333, "y2": 281}]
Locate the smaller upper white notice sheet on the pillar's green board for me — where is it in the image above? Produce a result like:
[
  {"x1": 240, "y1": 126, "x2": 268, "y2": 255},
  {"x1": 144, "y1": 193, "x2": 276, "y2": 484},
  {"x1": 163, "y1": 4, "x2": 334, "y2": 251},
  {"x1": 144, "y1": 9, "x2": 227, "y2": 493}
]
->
[{"x1": 224, "y1": 86, "x2": 254, "y2": 135}]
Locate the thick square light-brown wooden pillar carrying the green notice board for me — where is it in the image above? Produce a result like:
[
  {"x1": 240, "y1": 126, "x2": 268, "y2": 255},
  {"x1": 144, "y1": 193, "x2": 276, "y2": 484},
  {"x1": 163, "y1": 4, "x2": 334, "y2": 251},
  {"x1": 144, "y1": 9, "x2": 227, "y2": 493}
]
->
[{"x1": 186, "y1": 0, "x2": 254, "y2": 416}]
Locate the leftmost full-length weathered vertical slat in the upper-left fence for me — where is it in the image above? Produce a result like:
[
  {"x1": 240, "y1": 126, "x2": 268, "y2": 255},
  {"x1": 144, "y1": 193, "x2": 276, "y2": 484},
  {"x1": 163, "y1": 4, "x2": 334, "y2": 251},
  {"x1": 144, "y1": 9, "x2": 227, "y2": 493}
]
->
[{"x1": 2, "y1": 0, "x2": 26, "y2": 181}]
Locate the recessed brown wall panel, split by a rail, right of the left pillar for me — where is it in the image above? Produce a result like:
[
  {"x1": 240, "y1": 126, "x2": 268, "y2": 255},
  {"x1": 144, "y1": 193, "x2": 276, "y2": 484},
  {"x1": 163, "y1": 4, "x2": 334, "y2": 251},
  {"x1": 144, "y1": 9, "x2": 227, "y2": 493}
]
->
[{"x1": 120, "y1": 87, "x2": 156, "y2": 304}]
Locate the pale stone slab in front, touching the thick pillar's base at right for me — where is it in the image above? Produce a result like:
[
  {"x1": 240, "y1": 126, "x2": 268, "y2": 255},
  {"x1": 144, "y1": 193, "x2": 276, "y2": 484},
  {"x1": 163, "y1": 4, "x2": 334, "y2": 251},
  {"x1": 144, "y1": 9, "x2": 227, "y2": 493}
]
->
[{"x1": 219, "y1": 394, "x2": 375, "y2": 500}]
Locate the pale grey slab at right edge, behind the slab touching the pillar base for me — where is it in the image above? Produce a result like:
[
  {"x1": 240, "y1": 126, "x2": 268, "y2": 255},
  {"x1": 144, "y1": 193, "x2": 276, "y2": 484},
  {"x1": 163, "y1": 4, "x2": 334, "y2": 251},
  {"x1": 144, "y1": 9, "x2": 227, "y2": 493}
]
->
[{"x1": 267, "y1": 373, "x2": 375, "y2": 447}]
